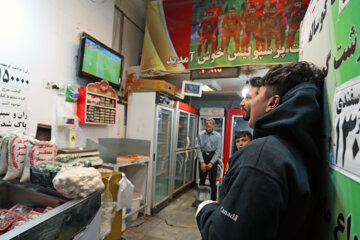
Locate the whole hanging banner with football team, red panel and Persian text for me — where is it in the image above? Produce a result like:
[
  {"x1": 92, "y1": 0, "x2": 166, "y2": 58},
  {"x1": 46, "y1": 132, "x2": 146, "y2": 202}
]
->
[{"x1": 140, "y1": 0, "x2": 309, "y2": 72}]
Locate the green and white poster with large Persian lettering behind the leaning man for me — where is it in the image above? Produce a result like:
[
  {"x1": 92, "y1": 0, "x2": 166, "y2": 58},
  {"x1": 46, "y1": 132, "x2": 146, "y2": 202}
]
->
[{"x1": 299, "y1": 0, "x2": 360, "y2": 237}]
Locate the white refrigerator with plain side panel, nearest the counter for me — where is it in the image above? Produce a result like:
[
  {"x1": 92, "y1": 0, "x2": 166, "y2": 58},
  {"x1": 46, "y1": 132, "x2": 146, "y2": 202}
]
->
[{"x1": 126, "y1": 92, "x2": 176, "y2": 212}]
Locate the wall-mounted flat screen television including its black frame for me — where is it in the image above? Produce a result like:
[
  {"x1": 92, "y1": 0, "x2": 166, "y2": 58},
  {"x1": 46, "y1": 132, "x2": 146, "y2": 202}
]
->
[{"x1": 78, "y1": 33, "x2": 124, "y2": 90}]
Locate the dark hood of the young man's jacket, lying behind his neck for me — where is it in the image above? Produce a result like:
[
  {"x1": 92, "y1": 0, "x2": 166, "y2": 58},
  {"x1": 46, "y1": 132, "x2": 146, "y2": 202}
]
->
[{"x1": 254, "y1": 82, "x2": 322, "y2": 158}]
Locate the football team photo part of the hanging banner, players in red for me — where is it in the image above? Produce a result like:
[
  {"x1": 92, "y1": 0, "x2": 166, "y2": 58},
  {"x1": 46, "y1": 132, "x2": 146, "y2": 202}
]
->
[{"x1": 189, "y1": 0, "x2": 308, "y2": 68}]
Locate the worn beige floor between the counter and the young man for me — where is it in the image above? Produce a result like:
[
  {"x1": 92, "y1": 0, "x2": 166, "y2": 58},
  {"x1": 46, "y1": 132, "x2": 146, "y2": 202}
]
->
[{"x1": 122, "y1": 188, "x2": 201, "y2": 240}]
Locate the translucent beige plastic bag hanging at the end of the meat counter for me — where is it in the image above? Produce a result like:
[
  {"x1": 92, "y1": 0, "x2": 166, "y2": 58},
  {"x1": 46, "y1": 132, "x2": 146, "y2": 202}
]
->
[{"x1": 100, "y1": 177, "x2": 116, "y2": 239}]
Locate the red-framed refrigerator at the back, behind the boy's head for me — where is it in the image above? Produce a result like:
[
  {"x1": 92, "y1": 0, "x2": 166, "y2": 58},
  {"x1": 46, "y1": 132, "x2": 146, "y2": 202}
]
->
[{"x1": 224, "y1": 109, "x2": 253, "y2": 172}]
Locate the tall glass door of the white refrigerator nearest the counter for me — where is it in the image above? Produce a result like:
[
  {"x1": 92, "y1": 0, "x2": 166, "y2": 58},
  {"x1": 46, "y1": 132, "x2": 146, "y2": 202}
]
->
[{"x1": 154, "y1": 107, "x2": 173, "y2": 206}]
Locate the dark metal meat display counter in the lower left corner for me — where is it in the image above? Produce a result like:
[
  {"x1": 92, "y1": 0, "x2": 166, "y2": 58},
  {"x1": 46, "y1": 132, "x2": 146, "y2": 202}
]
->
[{"x1": 0, "y1": 179, "x2": 101, "y2": 240}]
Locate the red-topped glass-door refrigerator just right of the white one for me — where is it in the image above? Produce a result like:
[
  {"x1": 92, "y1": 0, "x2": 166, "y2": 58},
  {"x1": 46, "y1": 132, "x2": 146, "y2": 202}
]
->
[{"x1": 171, "y1": 102, "x2": 199, "y2": 196}]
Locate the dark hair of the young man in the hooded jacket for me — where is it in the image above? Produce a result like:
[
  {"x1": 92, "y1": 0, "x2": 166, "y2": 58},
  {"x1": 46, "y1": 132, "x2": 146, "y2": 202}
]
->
[{"x1": 260, "y1": 61, "x2": 325, "y2": 98}]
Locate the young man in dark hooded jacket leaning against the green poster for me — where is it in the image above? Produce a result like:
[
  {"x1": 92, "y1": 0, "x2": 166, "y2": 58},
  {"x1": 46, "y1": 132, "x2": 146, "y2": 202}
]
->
[{"x1": 196, "y1": 62, "x2": 324, "y2": 240}]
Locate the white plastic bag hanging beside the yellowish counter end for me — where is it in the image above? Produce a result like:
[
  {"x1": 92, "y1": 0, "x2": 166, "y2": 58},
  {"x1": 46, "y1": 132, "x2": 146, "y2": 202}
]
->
[{"x1": 116, "y1": 173, "x2": 134, "y2": 211}]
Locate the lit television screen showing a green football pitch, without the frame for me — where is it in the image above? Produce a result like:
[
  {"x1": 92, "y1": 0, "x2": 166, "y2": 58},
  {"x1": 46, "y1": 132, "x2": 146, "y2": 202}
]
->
[{"x1": 82, "y1": 38, "x2": 123, "y2": 85}]
